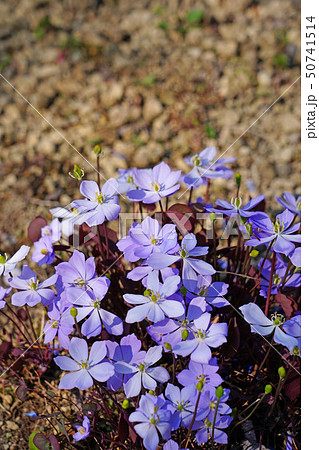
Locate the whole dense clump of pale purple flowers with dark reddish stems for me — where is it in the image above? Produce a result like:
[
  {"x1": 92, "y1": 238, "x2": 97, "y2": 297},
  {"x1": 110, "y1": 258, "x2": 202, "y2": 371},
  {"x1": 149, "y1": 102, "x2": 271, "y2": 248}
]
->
[{"x1": 0, "y1": 153, "x2": 301, "y2": 450}]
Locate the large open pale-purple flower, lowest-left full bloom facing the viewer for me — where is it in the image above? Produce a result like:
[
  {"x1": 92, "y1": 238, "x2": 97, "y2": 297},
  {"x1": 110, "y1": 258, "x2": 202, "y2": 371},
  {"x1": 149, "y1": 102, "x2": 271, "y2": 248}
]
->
[{"x1": 54, "y1": 337, "x2": 114, "y2": 389}]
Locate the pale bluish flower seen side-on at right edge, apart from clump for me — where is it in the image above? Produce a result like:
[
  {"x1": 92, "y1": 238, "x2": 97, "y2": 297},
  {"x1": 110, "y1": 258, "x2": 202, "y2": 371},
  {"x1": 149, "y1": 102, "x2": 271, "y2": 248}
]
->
[{"x1": 239, "y1": 303, "x2": 298, "y2": 352}]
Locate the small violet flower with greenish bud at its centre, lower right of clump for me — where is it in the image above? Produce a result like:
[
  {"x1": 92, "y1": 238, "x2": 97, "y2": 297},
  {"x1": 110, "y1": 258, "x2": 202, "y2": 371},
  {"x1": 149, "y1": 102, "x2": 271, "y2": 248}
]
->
[{"x1": 177, "y1": 358, "x2": 223, "y2": 392}]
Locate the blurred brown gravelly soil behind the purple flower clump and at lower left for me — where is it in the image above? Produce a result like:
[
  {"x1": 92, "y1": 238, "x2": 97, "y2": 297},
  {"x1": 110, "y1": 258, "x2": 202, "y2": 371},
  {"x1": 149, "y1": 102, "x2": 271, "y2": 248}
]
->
[{"x1": 0, "y1": 0, "x2": 300, "y2": 449}]
